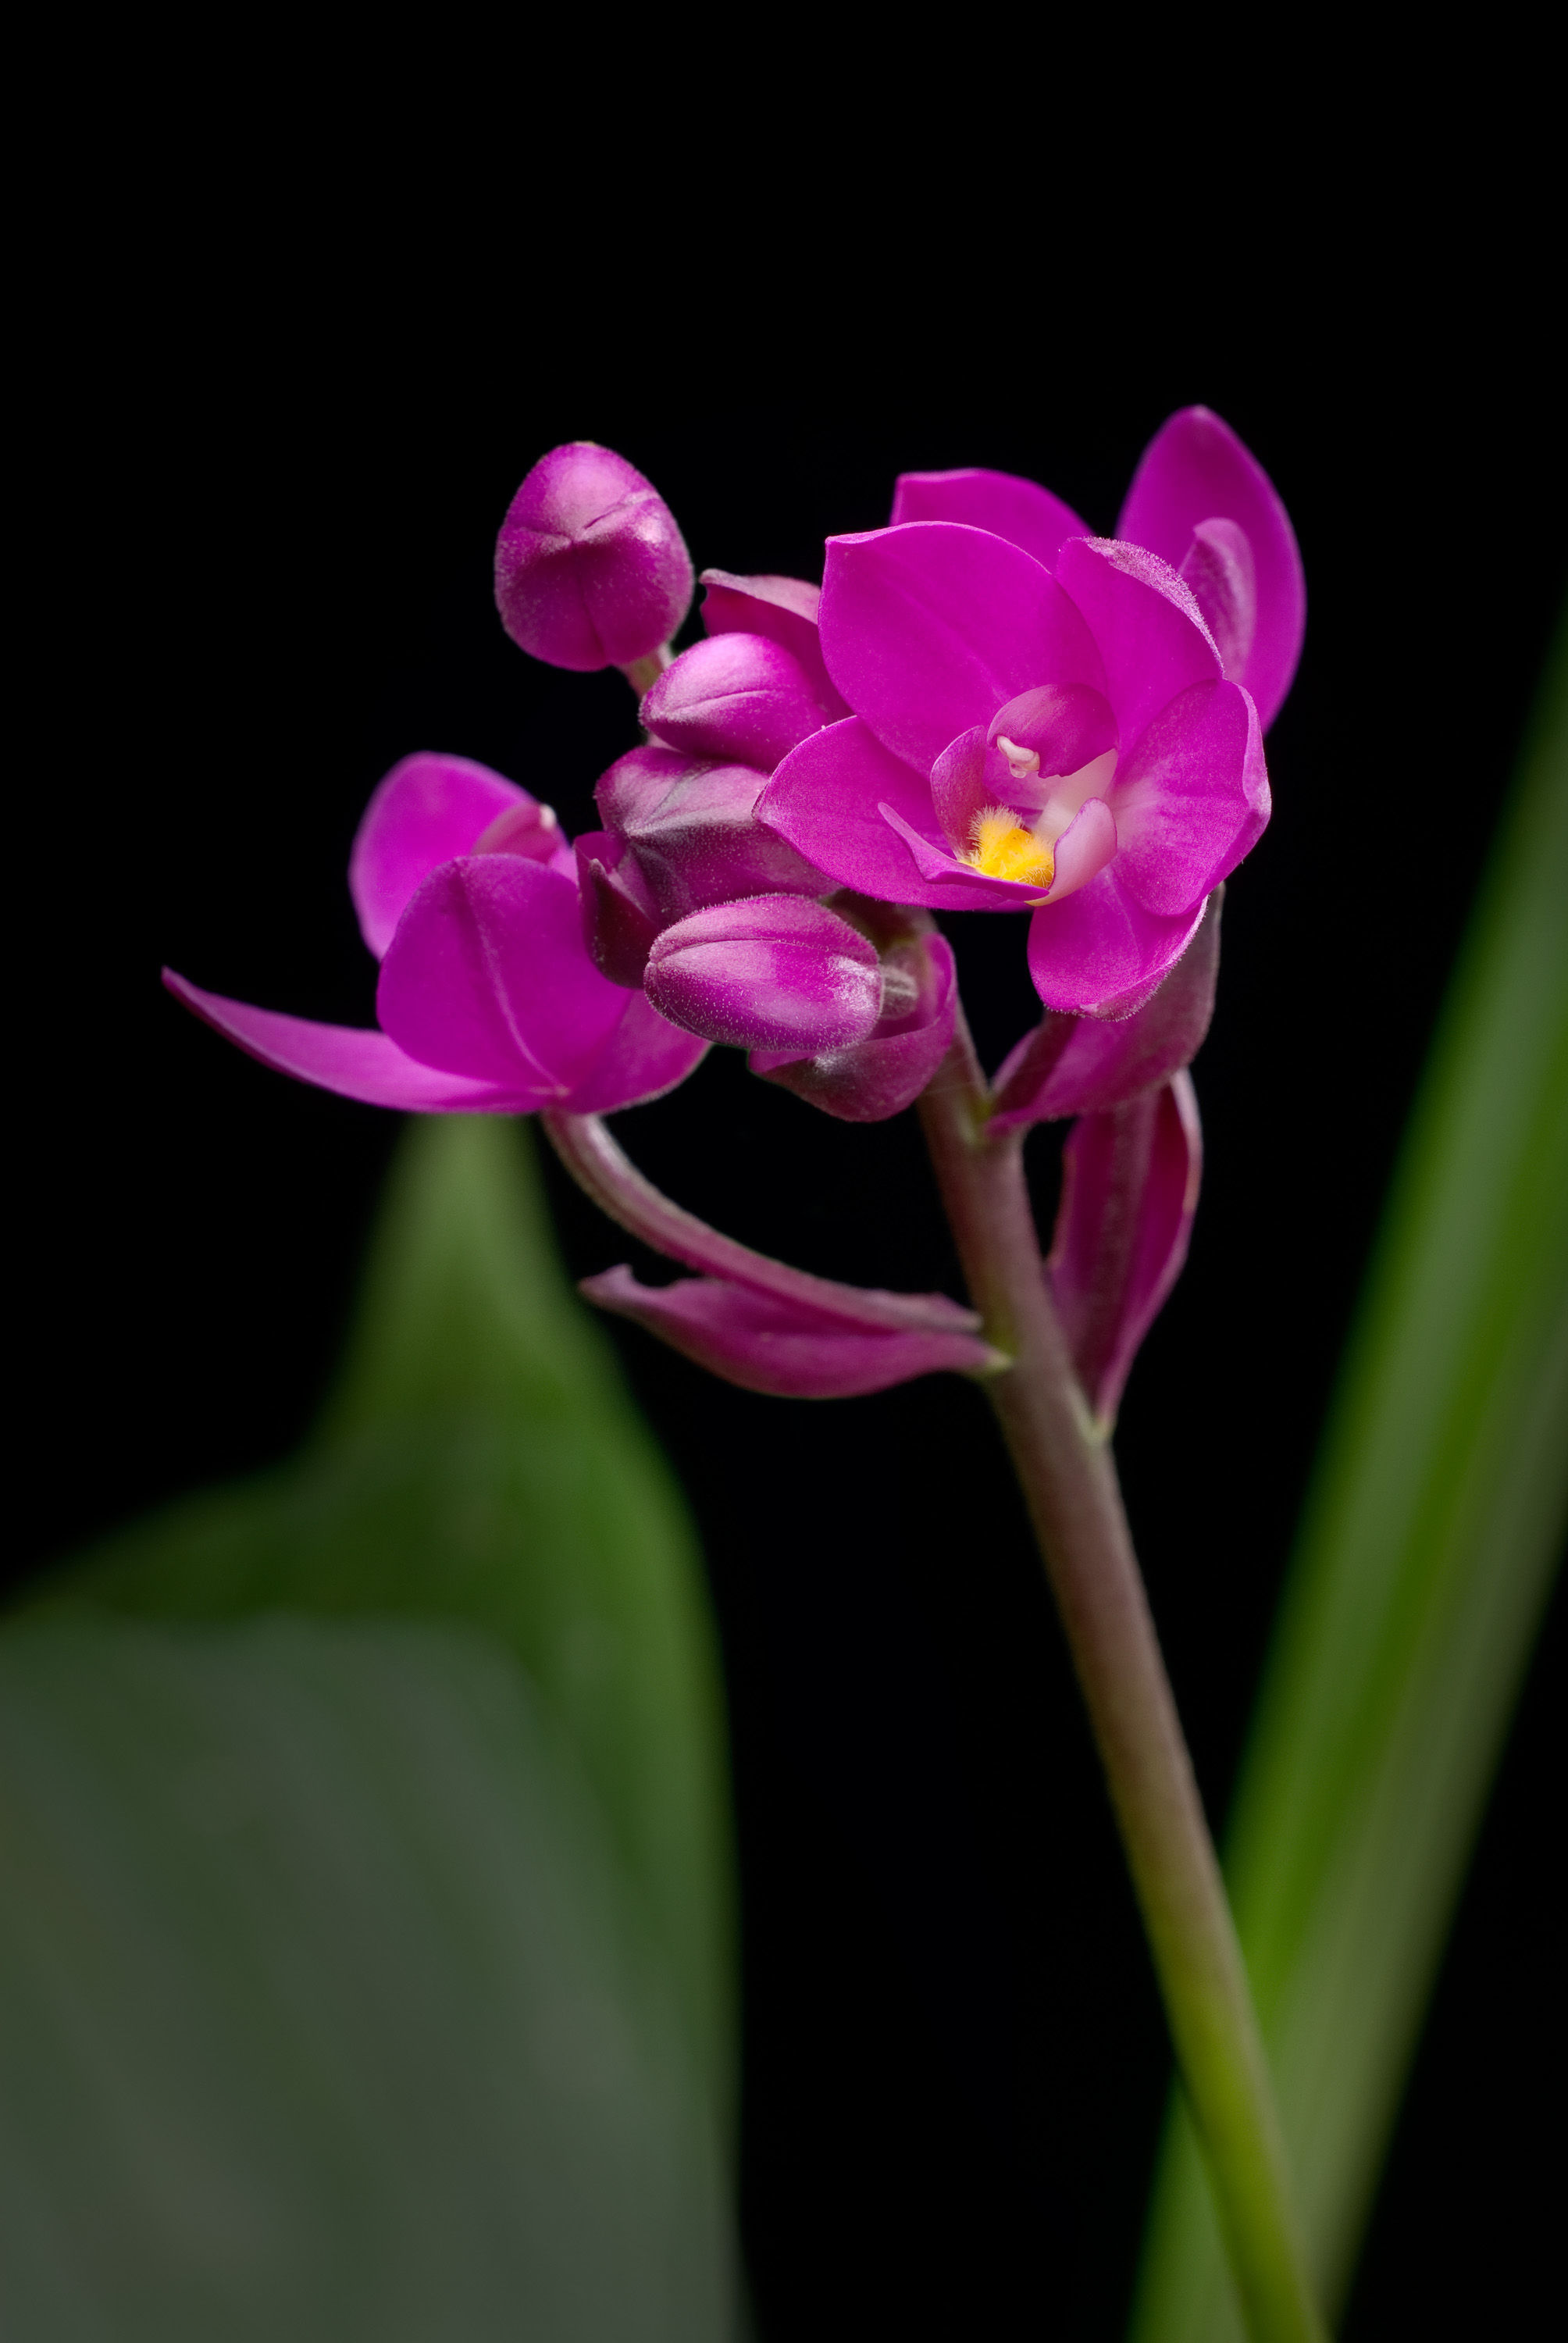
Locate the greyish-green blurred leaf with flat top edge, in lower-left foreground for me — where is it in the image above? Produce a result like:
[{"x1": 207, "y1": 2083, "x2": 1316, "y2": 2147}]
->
[{"x1": 0, "y1": 1617, "x2": 733, "y2": 2343}]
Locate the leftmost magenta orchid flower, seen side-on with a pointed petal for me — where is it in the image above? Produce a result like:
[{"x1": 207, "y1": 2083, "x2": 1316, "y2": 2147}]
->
[{"x1": 164, "y1": 754, "x2": 705, "y2": 1115}]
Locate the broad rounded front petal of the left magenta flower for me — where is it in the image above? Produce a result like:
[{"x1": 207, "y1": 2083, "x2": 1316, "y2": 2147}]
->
[{"x1": 377, "y1": 855, "x2": 625, "y2": 1092}]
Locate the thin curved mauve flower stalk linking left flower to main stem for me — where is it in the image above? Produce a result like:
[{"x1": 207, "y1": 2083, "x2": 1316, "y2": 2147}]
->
[{"x1": 539, "y1": 1111, "x2": 980, "y2": 1333}]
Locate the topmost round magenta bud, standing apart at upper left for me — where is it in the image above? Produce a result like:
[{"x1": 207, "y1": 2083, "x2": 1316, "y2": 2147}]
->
[{"x1": 494, "y1": 440, "x2": 691, "y2": 672}]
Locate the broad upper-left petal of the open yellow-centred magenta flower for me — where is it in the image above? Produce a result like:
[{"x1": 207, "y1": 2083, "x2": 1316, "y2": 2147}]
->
[{"x1": 823, "y1": 520, "x2": 1101, "y2": 773}]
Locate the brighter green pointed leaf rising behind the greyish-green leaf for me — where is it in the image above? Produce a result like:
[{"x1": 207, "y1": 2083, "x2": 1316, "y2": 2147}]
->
[{"x1": 40, "y1": 1115, "x2": 733, "y2": 2106}]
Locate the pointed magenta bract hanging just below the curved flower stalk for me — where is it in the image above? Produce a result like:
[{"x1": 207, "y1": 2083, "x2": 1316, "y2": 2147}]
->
[{"x1": 581, "y1": 1268, "x2": 999, "y2": 1399}]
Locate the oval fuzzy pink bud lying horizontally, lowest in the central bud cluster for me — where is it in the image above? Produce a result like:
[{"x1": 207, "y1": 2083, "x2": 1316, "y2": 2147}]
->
[{"x1": 644, "y1": 895, "x2": 882, "y2": 1054}]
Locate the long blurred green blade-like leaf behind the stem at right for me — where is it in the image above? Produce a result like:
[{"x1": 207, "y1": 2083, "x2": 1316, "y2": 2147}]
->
[{"x1": 1132, "y1": 614, "x2": 1568, "y2": 2343}]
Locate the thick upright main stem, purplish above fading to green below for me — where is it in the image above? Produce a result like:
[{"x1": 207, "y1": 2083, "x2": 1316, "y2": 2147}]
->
[{"x1": 921, "y1": 1019, "x2": 1327, "y2": 2343}]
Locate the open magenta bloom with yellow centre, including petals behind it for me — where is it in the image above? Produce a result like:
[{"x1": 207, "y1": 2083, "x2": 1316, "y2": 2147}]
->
[{"x1": 757, "y1": 410, "x2": 1306, "y2": 1017}]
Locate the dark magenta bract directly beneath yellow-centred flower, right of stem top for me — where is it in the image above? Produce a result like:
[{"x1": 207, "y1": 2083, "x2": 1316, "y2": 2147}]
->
[{"x1": 987, "y1": 888, "x2": 1226, "y2": 1132}]
